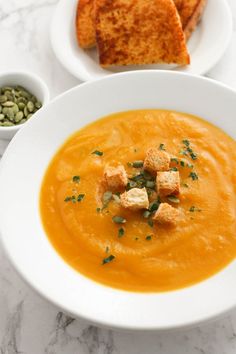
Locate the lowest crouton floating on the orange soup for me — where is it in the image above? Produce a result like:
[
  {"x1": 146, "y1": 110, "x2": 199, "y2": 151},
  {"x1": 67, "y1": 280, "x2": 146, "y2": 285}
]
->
[{"x1": 153, "y1": 203, "x2": 179, "y2": 225}]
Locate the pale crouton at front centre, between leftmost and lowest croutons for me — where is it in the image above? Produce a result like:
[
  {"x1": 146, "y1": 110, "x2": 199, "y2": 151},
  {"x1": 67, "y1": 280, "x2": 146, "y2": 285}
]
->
[{"x1": 120, "y1": 188, "x2": 149, "y2": 210}]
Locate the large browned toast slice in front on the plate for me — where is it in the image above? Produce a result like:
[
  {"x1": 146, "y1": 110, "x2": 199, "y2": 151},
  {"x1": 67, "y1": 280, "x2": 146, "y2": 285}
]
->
[{"x1": 95, "y1": 0, "x2": 190, "y2": 67}]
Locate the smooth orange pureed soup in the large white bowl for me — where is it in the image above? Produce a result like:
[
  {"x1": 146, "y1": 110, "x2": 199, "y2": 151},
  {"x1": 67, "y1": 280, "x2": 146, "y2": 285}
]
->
[{"x1": 40, "y1": 110, "x2": 236, "y2": 292}]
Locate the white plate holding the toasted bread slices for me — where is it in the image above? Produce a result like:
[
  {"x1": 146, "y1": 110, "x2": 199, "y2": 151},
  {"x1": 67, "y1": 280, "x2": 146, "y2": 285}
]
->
[{"x1": 51, "y1": 0, "x2": 232, "y2": 81}]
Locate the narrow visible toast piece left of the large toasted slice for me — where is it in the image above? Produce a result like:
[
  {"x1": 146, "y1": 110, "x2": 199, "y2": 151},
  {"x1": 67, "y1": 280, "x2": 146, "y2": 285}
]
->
[{"x1": 76, "y1": 0, "x2": 95, "y2": 48}]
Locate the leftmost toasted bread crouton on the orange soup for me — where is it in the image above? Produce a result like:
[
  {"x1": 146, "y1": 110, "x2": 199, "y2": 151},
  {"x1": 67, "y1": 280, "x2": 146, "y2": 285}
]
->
[{"x1": 104, "y1": 165, "x2": 128, "y2": 190}]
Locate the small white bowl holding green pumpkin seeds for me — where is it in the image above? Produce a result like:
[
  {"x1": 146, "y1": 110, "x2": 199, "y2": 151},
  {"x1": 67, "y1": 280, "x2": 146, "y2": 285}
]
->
[{"x1": 0, "y1": 71, "x2": 49, "y2": 141}]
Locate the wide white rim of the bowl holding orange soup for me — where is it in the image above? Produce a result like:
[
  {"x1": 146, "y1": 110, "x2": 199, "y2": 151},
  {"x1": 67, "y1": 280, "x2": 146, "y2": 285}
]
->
[{"x1": 0, "y1": 71, "x2": 236, "y2": 330}]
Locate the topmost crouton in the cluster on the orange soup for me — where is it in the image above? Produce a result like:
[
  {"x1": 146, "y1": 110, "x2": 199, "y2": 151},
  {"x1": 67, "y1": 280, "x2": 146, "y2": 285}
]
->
[{"x1": 144, "y1": 148, "x2": 170, "y2": 172}]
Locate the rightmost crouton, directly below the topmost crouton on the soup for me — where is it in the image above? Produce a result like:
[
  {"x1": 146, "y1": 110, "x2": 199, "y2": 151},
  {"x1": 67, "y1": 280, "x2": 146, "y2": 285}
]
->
[{"x1": 156, "y1": 171, "x2": 180, "y2": 197}]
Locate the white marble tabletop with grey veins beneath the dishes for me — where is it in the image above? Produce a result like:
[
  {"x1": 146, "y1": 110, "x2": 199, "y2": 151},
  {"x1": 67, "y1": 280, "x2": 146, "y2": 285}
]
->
[{"x1": 0, "y1": 0, "x2": 236, "y2": 354}]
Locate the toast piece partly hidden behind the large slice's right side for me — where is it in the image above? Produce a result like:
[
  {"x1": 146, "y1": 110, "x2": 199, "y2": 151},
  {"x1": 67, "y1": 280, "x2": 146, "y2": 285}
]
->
[{"x1": 174, "y1": 0, "x2": 207, "y2": 40}]
